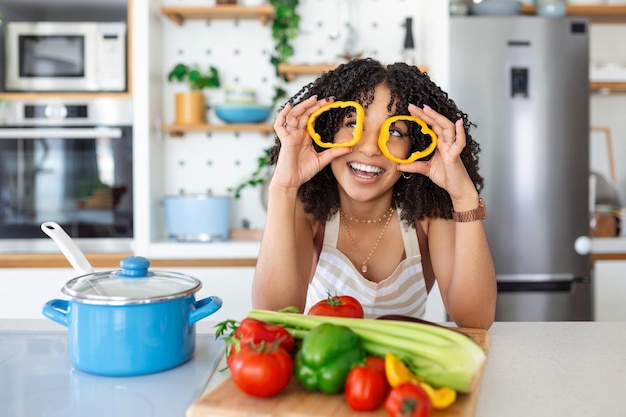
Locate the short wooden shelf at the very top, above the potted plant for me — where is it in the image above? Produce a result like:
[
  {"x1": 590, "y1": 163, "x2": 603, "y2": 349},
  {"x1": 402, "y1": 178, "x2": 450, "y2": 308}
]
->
[{"x1": 161, "y1": 4, "x2": 274, "y2": 26}]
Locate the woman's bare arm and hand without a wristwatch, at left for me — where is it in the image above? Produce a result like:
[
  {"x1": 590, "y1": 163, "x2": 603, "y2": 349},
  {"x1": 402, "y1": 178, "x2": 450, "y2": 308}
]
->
[{"x1": 252, "y1": 96, "x2": 350, "y2": 311}]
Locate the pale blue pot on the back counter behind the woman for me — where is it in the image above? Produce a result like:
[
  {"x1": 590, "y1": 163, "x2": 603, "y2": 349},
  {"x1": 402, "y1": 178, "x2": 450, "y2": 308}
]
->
[{"x1": 164, "y1": 194, "x2": 231, "y2": 242}]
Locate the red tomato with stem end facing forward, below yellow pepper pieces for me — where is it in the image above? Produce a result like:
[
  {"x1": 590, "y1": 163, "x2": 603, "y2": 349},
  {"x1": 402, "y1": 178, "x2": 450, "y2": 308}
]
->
[{"x1": 385, "y1": 382, "x2": 433, "y2": 417}]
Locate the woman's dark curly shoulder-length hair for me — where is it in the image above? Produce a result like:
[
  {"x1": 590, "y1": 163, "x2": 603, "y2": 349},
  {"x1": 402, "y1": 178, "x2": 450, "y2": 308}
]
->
[{"x1": 270, "y1": 58, "x2": 483, "y2": 225}]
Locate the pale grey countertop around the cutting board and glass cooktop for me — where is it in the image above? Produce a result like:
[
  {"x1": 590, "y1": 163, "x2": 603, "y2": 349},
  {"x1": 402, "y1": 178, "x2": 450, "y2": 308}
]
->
[{"x1": 0, "y1": 319, "x2": 626, "y2": 417}]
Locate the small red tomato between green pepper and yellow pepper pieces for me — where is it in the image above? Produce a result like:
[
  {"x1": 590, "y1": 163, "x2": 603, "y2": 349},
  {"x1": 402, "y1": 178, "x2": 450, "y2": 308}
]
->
[{"x1": 344, "y1": 366, "x2": 387, "y2": 411}]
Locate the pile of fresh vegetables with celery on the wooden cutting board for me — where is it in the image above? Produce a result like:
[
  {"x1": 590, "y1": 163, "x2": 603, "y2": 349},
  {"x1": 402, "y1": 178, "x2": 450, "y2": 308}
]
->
[{"x1": 217, "y1": 296, "x2": 486, "y2": 416}]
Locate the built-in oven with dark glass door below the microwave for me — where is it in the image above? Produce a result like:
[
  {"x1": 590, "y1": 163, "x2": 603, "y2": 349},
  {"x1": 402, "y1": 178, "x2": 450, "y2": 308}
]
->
[{"x1": 0, "y1": 98, "x2": 133, "y2": 243}]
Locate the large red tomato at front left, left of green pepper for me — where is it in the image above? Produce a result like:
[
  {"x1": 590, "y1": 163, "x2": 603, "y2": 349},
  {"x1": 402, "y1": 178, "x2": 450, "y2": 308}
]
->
[{"x1": 228, "y1": 345, "x2": 293, "y2": 397}]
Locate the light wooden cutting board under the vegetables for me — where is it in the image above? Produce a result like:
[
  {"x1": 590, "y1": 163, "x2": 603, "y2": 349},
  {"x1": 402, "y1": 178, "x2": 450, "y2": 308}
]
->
[{"x1": 187, "y1": 328, "x2": 489, "y2": 417}]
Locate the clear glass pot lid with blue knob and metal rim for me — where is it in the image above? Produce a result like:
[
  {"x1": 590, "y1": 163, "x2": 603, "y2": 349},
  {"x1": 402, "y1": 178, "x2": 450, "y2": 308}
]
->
[{"x1": 62, "y1": 256, "x2": 202, "y2": 305}]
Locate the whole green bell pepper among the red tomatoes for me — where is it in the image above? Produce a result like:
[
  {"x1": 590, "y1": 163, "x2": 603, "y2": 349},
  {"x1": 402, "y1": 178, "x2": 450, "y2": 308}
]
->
[{"x1": 295, "y1": 323, "x2": 365, "y2": 394}]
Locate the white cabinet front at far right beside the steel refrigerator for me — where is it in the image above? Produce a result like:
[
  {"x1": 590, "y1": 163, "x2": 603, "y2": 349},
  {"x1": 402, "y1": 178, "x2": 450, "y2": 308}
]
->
[{"x1": 593, "y1": 261, "x2": 626, "y2": 321}]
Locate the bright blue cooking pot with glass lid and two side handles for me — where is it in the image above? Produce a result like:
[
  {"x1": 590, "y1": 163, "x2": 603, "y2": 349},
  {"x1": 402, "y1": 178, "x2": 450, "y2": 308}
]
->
[{"x1": 43, "y1": 257, "x2": 222, "y2": 376}]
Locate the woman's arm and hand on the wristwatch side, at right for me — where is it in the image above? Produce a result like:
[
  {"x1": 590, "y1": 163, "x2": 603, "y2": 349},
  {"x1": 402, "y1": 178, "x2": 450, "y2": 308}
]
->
[{"x1": 399, "y1": 106, "x2": 497, "y2": 329}]
